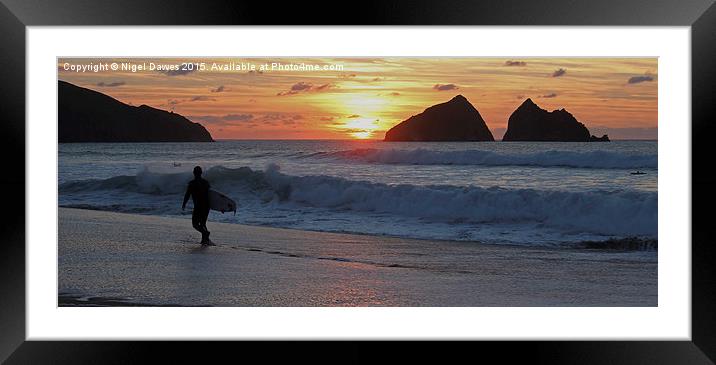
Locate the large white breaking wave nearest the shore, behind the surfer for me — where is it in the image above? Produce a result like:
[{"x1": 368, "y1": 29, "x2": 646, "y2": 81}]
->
[{"x1": 59, "y1": 164, "x2": 658, "y2": 237}]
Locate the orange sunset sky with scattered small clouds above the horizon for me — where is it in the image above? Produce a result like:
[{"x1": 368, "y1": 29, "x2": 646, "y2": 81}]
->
[{"x1": 58, "y1": 58, "x2": 658, "y2": 139}]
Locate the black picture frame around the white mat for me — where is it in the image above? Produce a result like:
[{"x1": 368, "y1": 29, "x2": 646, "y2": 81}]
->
[{"x1": 0, "y1": 0, "x2": 716, "y2": 364}]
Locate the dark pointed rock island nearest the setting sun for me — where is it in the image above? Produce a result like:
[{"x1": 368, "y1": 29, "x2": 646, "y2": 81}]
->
[{"x1": 385, "y1": 95, "x2": 495, "y2": 142}]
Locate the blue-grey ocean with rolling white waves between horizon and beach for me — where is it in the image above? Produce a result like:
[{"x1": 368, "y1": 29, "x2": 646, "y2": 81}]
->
[{"x1": 58, "y1": 140, "x2": 658, "y2": 248}]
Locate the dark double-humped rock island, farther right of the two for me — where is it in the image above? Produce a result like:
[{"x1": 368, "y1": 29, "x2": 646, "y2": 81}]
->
[{"x1": 502, "y1": 99, "x2": 609, "y2": 142}]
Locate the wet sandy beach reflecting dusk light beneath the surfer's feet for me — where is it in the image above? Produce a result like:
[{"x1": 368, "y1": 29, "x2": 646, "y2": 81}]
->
[{"x1": 58, "y1": 207, "x2": 658, "y2": 307}]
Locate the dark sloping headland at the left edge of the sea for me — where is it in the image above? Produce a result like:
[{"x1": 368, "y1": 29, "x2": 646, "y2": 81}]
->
[{"x1": 57, "y1": 81, "x2": 214, "y2": 143}]
